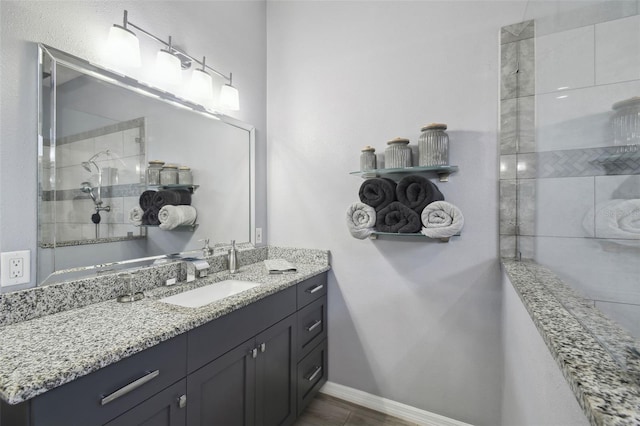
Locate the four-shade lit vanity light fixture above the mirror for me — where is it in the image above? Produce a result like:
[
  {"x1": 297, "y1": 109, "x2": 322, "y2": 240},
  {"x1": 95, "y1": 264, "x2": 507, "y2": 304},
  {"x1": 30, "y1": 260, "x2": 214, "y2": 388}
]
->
[{"x1": 107, "y1": 10, "x2": 239, "y2": 111}]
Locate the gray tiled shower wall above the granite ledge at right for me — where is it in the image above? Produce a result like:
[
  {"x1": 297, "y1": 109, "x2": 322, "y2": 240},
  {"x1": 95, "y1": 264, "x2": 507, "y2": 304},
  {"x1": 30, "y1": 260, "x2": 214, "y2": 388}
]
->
[{"x1": 500, "y1": 9, "x2": 640, "y2": 336}]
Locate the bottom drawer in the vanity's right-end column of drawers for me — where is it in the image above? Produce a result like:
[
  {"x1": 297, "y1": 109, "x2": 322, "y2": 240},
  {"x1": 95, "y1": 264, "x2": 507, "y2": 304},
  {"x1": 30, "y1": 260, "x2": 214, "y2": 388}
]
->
[{"x1": 297, "y1": 339, "x2": 327, "y2": 415}]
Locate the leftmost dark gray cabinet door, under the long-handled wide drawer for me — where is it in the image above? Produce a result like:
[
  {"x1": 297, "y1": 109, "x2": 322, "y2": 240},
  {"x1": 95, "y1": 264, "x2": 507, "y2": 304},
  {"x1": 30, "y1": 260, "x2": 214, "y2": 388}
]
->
[{"x1": 105, "y1": 379, "x2": 187, "y2": 426}]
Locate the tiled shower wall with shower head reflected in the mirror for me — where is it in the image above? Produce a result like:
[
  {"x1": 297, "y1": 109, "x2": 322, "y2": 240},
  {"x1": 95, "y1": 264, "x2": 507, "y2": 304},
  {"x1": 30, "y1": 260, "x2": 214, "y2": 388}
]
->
[{"x1": 40, "y1": 118, "x2": 145, "y2": 247}]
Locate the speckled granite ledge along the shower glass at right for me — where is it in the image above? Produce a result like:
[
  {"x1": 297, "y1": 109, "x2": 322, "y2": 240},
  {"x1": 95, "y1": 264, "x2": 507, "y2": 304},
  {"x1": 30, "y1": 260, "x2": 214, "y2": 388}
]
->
[{"x1": 502, "y1": 259, "x2": 640, "y2": 425}]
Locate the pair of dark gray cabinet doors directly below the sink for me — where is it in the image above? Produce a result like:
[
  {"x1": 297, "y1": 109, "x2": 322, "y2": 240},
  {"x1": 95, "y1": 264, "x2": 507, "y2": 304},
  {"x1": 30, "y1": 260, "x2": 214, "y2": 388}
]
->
[{"x1": 187, "y1": 315, "x2": 296, "y2": 426}]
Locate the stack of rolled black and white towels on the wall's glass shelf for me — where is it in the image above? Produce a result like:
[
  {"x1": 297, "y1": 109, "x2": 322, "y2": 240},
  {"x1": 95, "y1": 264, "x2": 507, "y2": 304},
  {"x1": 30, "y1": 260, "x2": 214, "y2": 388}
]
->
[{"x1": 347, "y1": 175, "x2": 464, "y2": 239}]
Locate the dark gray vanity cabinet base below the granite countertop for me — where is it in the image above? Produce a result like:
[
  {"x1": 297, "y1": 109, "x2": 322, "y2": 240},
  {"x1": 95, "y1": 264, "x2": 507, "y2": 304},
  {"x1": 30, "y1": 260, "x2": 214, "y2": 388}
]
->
[{"x1": 0, "y1": 273, "x2": 327, "y2": 426}]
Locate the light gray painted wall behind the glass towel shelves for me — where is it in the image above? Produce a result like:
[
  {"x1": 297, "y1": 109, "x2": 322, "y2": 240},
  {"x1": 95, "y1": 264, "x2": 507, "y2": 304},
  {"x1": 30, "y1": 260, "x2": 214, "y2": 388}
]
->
[{"x1": 267, "y1": 1, "x2": 525, "y2": 425}]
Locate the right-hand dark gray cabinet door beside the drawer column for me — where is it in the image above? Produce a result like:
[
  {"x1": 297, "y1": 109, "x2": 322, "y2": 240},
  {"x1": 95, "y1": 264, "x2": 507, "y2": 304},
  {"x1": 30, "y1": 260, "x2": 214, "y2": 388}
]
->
[{"x1": 256, "y1": 315, "x2": 296, "y2": 426}]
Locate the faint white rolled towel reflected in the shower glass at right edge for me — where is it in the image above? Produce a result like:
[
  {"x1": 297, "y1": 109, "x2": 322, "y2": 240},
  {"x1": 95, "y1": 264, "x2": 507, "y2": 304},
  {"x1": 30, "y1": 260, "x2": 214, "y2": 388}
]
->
[{"x1": 582, "y1": 198, "x2": 640, "y2": 240}]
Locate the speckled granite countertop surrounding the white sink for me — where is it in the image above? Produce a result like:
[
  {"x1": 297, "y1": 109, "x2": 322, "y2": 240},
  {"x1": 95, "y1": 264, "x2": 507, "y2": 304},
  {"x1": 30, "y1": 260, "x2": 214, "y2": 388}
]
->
[{"x1": 0, "y1": 262, "x2": 330, "y2": 404}]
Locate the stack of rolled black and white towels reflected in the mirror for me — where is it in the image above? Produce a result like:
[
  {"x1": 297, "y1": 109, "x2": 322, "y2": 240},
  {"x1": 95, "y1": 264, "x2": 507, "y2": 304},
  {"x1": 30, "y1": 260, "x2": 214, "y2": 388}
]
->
[{"x1": 129, "y1": 189, "x2": 197, "y2": 231}]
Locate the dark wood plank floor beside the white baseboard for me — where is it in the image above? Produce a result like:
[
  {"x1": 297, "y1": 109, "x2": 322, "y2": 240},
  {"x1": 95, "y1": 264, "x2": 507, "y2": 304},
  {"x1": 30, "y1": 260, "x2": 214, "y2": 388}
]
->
[{"x1": 294, "y1": 393, "x2": 417, "y2": 426}]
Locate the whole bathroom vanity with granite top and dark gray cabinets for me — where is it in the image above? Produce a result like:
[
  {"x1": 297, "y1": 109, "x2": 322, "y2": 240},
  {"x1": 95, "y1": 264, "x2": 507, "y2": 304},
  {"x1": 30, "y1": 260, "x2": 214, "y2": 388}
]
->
[{"x1": 0, "y1": 249, "x2": 329, "y2": 426}]
